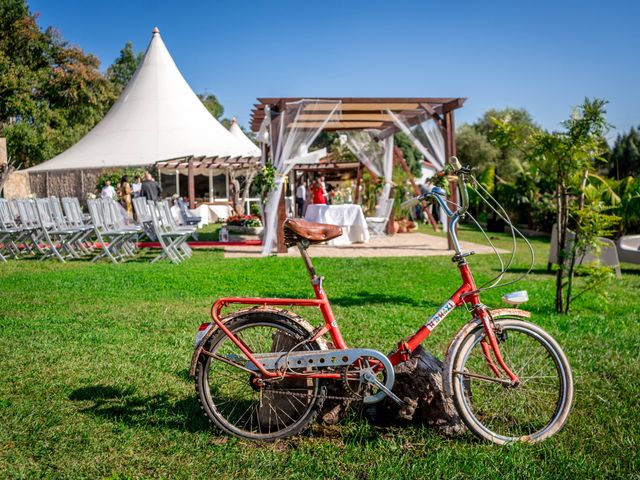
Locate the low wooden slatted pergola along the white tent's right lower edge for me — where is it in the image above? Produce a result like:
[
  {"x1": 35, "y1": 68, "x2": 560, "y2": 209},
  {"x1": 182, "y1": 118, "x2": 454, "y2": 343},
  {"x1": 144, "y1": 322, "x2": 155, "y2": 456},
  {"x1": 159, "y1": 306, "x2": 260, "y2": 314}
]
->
[{"x1": 156, "y1": 155, "x2": 260, "y2": 208}]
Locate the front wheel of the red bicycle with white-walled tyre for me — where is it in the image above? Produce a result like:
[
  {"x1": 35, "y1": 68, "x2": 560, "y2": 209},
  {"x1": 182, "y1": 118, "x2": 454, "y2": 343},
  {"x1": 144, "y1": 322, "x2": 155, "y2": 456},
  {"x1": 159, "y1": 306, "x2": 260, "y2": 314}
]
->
[{"x1": 452, "y1": 319, "x2": 573, "y2": 444}]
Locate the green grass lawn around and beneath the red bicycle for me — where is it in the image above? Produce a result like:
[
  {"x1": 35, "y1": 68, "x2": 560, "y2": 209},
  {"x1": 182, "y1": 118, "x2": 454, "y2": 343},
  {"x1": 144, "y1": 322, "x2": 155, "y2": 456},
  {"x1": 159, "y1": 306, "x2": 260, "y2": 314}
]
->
[{"x1": 0, "y1": 227, "x2": 640, "y2": 479}]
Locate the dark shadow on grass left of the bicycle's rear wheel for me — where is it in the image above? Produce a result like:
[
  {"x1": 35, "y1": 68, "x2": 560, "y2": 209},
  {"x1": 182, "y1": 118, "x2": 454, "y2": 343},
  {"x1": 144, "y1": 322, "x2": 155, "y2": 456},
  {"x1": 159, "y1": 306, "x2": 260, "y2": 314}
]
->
[{"x1": 69, "y1": 385, "x2": 215, "y2": 433}]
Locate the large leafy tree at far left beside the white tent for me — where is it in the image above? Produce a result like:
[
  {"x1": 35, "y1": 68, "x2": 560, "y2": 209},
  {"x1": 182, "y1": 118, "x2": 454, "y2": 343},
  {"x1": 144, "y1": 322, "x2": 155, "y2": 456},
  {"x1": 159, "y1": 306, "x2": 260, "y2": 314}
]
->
[{"x1": 0, "y1": 0, "x2": 117, "y2": 167}]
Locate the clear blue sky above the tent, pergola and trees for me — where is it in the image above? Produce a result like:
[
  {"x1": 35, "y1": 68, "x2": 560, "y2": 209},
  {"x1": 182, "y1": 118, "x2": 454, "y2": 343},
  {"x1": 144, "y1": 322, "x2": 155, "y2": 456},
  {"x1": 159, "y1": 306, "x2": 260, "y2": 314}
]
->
[{"x1": 30, "y1": 0, "x2": 640, "y2": 141}]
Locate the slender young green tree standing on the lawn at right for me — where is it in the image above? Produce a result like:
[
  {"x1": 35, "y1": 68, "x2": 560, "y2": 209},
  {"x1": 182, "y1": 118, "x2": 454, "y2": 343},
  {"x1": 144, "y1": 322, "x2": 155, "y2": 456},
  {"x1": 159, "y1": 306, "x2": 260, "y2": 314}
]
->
[{"x1": 496, "y1": 99, "x2": 617, "y2": 314}]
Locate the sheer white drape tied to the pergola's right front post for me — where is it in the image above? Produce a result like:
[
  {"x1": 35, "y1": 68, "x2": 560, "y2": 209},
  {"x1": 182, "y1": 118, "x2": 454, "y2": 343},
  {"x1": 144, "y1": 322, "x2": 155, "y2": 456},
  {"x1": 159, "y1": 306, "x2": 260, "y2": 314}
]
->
[{"x1": 387, "y1": 110, "x2": 447, "y2": 232}]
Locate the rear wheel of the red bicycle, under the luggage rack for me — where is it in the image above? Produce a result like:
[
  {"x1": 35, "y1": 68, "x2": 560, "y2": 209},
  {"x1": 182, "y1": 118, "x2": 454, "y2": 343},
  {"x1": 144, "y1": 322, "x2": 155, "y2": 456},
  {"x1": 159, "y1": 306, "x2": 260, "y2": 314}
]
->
[{"x1": 196, "y1": 312, "x2": 325, "y2": 441}]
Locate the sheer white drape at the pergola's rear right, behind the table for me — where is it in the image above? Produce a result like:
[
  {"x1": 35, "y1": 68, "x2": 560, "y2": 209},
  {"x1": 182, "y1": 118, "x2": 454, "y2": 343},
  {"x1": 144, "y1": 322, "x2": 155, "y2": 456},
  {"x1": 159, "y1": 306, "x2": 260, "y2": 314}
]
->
[{"x1": 342, "y1": 130, "x2": 394, "y2": 199}]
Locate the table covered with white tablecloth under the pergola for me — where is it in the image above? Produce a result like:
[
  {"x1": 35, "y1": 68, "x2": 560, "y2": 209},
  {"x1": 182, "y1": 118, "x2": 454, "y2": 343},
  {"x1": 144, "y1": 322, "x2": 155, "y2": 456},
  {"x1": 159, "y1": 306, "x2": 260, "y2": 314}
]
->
[{"x1": 304, "y1": 204, "x2": 369, "y2": 245}]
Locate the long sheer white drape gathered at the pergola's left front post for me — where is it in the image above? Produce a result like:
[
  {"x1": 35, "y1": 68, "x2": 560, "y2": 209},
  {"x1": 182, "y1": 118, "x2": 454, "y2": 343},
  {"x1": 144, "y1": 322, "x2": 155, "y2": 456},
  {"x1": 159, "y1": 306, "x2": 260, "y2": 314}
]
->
[{"x1": 261, "y1": 100, "x2": 340, "y2": 255}]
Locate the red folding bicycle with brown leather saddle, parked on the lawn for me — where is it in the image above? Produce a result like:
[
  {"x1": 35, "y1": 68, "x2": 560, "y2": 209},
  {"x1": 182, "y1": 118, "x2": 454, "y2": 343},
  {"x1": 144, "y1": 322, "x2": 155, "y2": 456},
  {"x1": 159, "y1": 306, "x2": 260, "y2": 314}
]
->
[{"x1": 191, "y1": 159, "x2": 573, "y2": 444}]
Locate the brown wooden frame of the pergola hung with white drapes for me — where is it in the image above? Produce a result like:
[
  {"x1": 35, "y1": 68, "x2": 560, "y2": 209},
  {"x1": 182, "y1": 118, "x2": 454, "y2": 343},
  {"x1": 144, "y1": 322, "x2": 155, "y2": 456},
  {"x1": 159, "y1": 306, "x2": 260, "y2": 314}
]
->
[{"x1": 251, "y1": 97, "x2": 466, "y2": 252}]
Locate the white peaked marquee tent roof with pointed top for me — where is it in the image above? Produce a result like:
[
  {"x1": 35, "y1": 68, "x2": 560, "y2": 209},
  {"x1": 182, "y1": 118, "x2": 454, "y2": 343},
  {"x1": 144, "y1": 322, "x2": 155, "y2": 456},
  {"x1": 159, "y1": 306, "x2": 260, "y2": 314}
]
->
[{"x1": 27, "y1": 28, "x2": 252, "y2": 172}]
